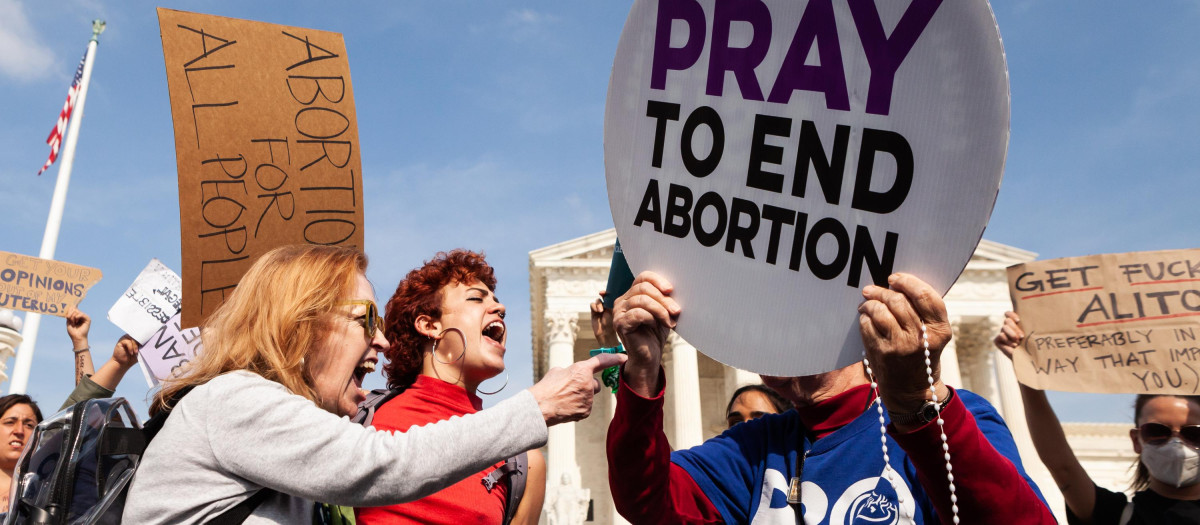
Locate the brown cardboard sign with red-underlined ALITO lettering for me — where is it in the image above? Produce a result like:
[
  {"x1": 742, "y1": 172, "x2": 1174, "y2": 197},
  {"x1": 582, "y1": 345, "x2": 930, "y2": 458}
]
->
[{"x1": 1008, "y1": 249, "x2": 1200, "y2": 394}]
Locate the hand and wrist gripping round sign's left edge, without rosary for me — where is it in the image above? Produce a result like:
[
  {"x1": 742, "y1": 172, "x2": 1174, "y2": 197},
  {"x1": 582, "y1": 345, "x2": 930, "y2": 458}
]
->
[{"x1": 613, "y1": 272, "x2": 680, "y2": 397}]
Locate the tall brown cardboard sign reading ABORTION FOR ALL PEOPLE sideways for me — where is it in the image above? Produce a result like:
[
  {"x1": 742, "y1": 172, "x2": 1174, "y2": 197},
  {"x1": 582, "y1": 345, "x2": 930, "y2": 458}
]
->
[{"x1": 158, "y1": 8, "x2": 362, "y2": 327}]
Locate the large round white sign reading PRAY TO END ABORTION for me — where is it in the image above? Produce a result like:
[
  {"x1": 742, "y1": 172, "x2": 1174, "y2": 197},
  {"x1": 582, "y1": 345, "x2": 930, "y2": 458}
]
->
[{"x1": 605, "y1": 0, "x2": 1009, "y2": 375}]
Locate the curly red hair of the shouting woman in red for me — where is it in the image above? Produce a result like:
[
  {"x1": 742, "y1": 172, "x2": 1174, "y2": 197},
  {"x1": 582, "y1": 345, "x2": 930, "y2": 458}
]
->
[{"x1": 383, "y1": 249, "x2": 496, "y2": 388}]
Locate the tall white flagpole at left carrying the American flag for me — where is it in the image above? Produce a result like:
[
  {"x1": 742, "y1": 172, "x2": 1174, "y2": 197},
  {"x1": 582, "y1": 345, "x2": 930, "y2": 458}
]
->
[{"x1": 8, "y1": 20, "x2": 104, "y2": 393}]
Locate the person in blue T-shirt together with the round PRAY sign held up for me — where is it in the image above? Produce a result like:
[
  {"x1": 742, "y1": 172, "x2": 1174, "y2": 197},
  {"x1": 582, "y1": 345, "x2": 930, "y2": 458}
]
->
[{"x1": 604, "y1": 0, "x2": 1054, "y2": 524}]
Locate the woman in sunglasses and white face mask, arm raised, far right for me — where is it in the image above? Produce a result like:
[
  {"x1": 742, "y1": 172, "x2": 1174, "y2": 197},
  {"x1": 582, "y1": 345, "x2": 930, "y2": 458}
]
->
[{"x1": 995, "y1": 312, "x2": 1200, "y2": 525}]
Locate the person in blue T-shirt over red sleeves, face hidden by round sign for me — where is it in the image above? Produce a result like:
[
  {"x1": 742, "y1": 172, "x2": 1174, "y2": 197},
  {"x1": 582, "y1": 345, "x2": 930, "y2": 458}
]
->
[{"x1": 607, "y1": 272, "x2": 1055, "y2": 524}]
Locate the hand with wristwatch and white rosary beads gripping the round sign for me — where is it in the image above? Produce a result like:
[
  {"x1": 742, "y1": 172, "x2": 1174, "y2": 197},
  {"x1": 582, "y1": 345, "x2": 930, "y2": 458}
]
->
[{"x1": 858, "y1": 273, "x2": 952, "y2": 414}]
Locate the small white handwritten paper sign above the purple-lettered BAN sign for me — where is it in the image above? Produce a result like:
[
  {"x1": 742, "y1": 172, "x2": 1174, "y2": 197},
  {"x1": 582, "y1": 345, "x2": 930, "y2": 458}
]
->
[{"x1": 108, "y1": 259, "x2": 184, "y2": 344}]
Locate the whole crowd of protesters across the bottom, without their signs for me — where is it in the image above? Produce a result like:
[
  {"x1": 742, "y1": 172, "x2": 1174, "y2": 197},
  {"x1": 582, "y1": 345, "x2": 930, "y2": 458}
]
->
[{"x1": 0, "y1": 246, "x2": 1200, "y2": 524}]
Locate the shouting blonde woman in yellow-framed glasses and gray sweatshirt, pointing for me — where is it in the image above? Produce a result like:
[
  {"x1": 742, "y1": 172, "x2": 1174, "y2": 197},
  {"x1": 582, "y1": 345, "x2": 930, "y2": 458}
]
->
[{"x1": 124, "y1": 246, "x2": 616, "y2": 524}]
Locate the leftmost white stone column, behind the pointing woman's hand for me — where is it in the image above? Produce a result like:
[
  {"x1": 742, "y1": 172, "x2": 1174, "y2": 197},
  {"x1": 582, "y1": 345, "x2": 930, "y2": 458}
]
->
[{"x1": 545, "y1": 312, "x2": 580, "y2": 489}]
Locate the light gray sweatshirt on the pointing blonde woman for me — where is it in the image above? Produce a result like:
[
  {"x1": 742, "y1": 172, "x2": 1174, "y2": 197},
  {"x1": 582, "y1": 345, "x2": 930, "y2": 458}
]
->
[{"x1": 122, "y1": 372, "x2": 547, "y2": 524}]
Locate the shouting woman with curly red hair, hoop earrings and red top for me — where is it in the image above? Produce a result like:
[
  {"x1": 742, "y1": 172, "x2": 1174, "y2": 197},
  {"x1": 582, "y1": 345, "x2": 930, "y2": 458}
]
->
[{"x1": 356, "y1": 249, "x2": 546, "y2": 525}]
